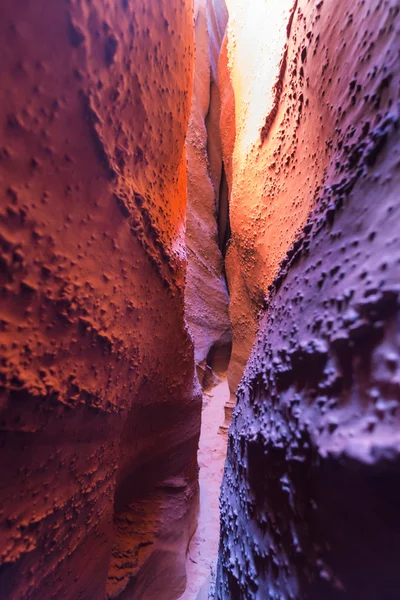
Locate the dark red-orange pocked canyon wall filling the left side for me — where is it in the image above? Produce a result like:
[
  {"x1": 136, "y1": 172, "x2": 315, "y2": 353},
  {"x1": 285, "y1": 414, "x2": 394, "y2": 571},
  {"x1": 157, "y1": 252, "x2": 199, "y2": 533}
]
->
[{"x1": 0, "y1": 0, "x2": 200, "y2": 600}]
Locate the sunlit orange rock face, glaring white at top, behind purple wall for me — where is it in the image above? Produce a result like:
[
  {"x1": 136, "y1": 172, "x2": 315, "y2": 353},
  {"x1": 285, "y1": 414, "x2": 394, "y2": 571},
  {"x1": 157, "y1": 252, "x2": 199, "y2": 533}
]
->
[{"x1": 219, "y1": 0, "x2": 296, "y2": 425}]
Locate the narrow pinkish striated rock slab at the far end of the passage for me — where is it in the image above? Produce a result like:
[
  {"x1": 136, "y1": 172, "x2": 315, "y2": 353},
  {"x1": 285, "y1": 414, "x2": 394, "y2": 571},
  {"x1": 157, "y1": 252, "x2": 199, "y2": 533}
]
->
[{"x1": 185, "y1": 0, "x2": 231, "y2": 387}]
